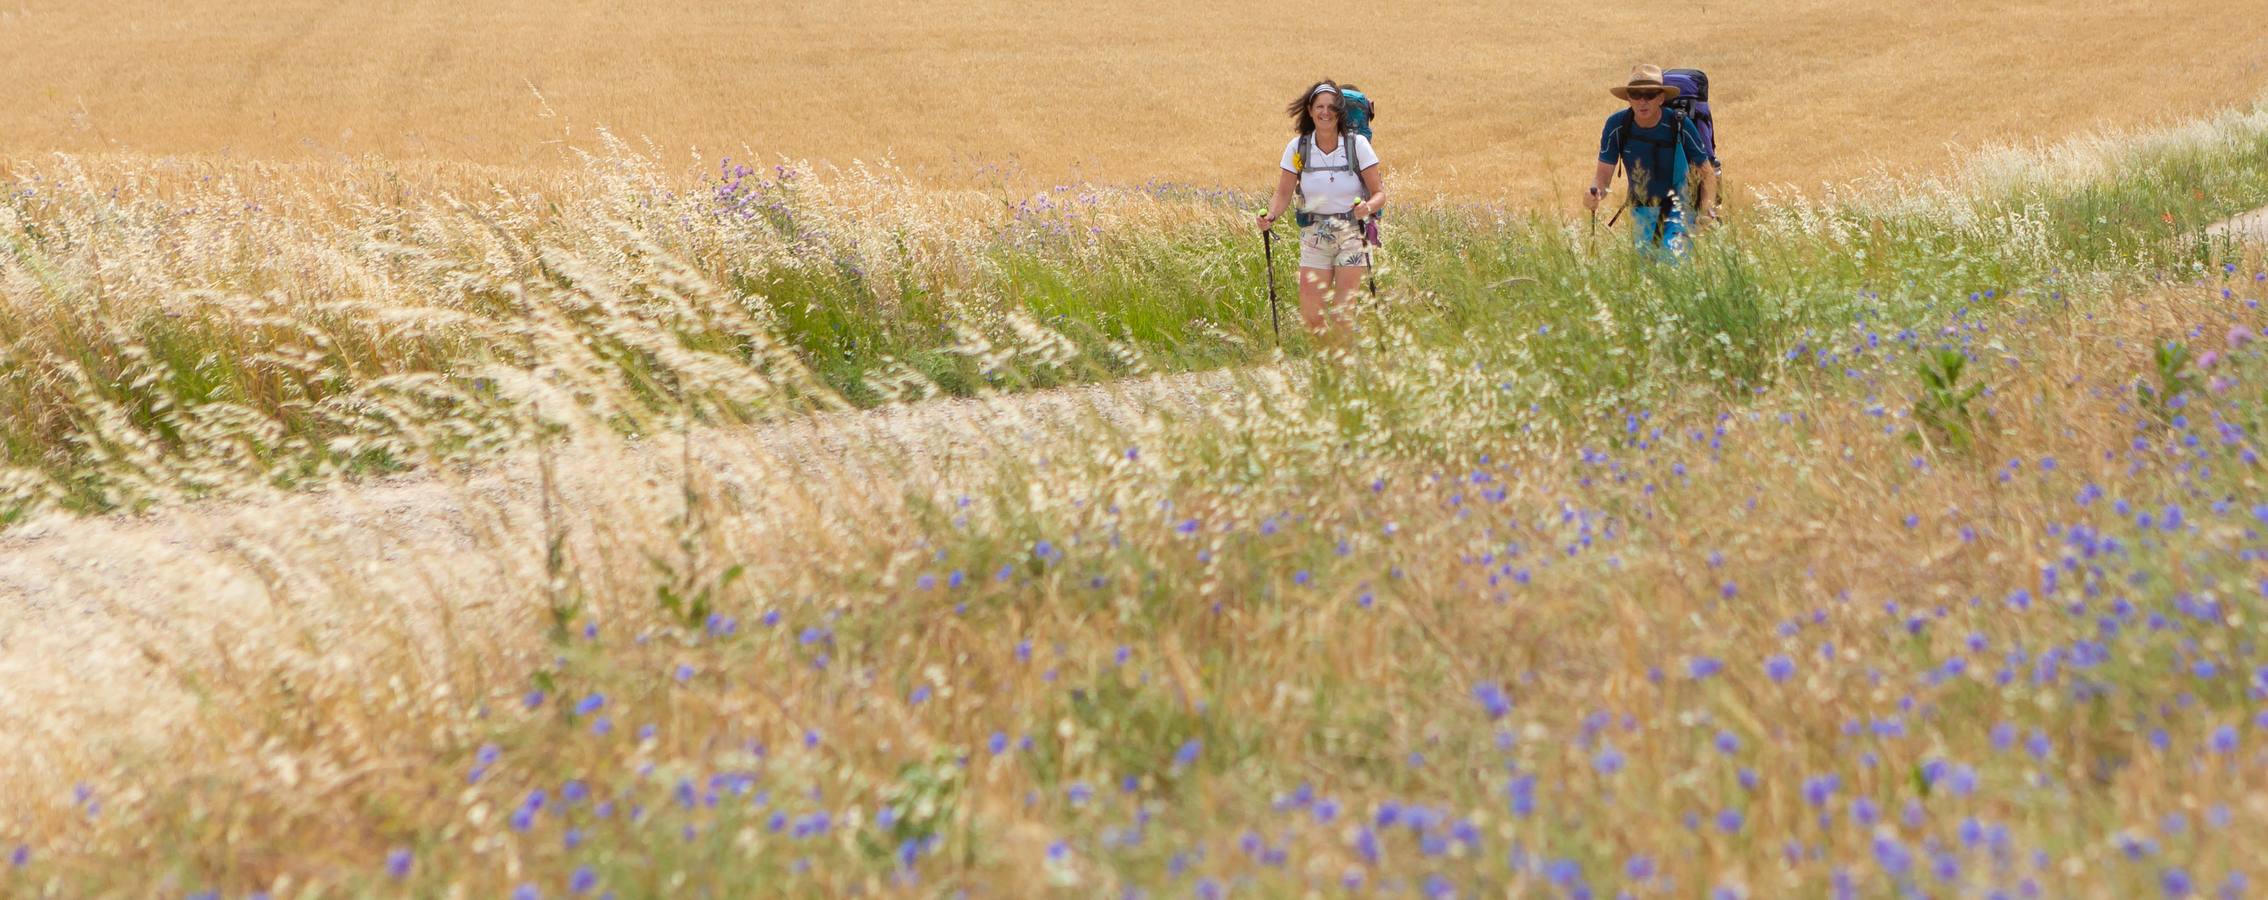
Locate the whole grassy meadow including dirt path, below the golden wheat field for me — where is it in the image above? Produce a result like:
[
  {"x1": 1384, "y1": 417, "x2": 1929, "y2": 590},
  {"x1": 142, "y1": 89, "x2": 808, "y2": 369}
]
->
[{"x1": 0, "y1": 68, "x2": 2268, "y2": 898}]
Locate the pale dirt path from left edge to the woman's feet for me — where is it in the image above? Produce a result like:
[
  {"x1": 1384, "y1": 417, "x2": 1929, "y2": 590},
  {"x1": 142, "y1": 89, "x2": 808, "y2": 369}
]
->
[{"x1": 0, "y1": 370, "x2": 1256, "y2": 782}]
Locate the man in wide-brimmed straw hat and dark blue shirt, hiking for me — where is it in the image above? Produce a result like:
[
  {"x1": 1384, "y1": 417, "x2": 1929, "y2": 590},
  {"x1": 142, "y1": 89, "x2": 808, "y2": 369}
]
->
[{"x1": 1583, "y1": 66, "x2": 1724, "y2": 258}]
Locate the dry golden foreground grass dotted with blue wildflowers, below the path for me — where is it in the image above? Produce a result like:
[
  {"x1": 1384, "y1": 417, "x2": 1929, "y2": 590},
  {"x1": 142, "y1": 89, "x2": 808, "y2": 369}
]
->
[{"x1": 0, "y1": 259, "x2": 2268, "y2": 895}]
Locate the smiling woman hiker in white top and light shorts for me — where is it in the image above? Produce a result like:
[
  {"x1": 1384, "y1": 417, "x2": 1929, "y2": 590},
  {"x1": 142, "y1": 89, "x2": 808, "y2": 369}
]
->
[{"x1": 1259, "y1": 79, "x2": 1386, "y2": 333}]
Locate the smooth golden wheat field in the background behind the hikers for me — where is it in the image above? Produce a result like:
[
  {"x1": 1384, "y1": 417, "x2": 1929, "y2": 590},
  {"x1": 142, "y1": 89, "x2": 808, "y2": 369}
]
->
[{"x1": 13, "y1": 0, "x2": 2268, "y2": 202}]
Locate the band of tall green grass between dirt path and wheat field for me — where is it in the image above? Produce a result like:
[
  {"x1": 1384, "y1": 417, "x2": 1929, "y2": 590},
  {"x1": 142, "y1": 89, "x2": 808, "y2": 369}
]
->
[{"x1": 0, "y1": 110, "x2": 2268, "y2": 517}]
